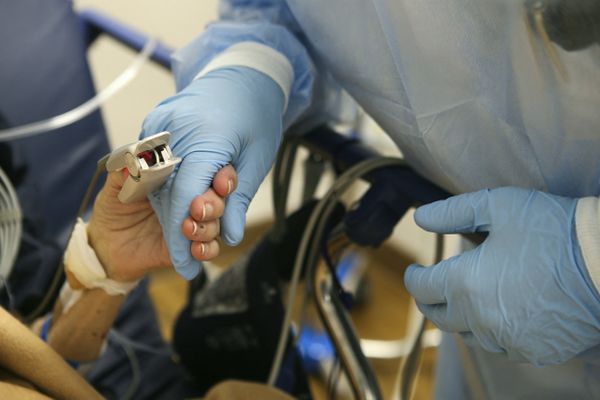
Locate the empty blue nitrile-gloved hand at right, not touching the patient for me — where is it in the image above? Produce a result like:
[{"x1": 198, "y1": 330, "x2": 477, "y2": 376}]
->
[{"x1": 404, "y1": 187, "x2": 600, "y2": 365}]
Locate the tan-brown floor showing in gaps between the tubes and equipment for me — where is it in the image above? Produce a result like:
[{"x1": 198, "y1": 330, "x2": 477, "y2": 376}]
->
[{"x1": 150, "y1": 225, "x2": 435, "y2": 400}]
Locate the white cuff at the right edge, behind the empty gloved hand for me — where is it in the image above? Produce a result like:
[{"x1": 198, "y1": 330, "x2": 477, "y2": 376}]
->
[{"x1": 575, "y1": 197, "x2": 600, "y2": 292}]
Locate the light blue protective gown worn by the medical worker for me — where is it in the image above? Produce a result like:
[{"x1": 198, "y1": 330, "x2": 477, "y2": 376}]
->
[{"x1": 174, "y1": 0, "x2": 600, "y2": 399}]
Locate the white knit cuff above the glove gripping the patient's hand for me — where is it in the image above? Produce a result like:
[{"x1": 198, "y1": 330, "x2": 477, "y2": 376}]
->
[{"x1": 194, "y1": 42, "x2": 294, "y2": 112}]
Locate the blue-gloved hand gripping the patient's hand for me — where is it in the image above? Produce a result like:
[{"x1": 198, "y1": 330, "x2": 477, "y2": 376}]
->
[{"x1": 141, "y1": 67, "x2": 285, "y2": 279}]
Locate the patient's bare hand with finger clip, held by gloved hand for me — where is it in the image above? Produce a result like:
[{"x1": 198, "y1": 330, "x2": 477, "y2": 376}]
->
[{"x1": 87, "y1": 166, "x2": 237, "y2": 281}]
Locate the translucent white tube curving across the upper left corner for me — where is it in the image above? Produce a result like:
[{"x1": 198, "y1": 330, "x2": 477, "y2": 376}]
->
[{"x1": 0, "y1": 39, "x2": 157, "y2": 142}]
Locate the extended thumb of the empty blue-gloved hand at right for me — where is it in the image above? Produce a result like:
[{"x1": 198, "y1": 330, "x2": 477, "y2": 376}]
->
[{"x1": 414, "y1": 190, "x2": 491, "y2": 233}]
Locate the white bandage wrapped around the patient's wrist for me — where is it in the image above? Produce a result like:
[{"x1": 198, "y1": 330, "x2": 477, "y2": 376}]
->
[{"x1": 64, "y1": 218, "x2": 139, "y2": 296}]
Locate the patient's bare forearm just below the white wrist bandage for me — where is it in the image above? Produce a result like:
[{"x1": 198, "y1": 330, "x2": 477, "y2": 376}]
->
[{"x1": 48, "y1": 289, "x2": 125, "y2": 362}]
